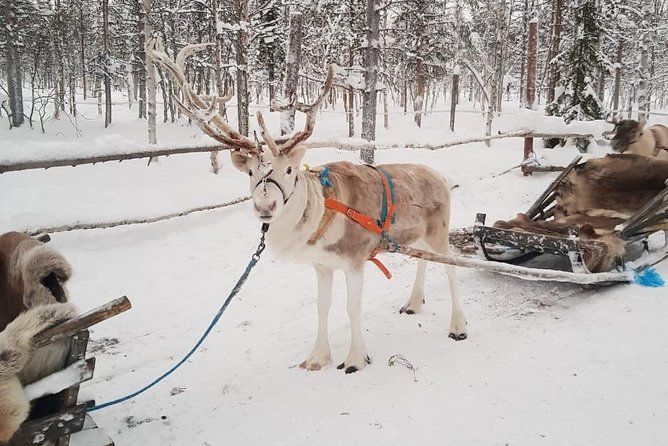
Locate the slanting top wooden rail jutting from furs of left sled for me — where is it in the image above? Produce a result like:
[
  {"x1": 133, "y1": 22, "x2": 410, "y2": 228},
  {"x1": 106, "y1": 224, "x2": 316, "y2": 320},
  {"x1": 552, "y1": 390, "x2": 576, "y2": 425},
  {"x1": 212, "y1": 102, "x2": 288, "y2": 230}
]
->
[{"x1": 33, "y1": 296, "x2": 132, "y2": 348}]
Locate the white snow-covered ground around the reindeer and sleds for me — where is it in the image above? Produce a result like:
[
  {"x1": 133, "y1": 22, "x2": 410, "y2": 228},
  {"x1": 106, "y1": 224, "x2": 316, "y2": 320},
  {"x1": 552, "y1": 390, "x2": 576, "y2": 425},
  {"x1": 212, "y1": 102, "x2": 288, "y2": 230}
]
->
[{"x1": 0, "y1": 98, "x2": 668, "y2": 446}]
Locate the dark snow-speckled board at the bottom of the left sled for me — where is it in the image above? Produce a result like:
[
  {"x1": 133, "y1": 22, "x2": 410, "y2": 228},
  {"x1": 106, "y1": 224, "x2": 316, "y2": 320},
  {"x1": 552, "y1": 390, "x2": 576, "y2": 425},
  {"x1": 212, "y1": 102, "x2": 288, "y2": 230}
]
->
[{"x1": 7, "y1": 402, "x2": 90, "y2": 446}]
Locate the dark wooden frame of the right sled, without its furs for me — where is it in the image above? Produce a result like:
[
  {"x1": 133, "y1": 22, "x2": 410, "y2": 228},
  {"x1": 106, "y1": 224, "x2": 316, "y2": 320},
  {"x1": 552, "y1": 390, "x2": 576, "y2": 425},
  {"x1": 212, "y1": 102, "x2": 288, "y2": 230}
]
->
[{"x1": 473, "y1": 156, "x2": 668, "y2": 285}]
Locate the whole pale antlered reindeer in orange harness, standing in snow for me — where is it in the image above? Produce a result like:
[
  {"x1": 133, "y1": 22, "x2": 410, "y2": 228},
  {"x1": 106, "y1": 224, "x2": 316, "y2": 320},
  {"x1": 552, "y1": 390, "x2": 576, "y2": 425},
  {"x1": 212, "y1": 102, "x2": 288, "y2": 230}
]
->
[{"x1": 147, "y1": 38, "x2": 467, "y2": 373}]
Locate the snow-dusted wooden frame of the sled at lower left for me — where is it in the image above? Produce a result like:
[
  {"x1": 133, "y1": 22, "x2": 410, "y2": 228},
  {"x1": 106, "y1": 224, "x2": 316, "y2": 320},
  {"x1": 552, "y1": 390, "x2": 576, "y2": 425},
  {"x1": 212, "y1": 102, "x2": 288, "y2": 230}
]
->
[{"x1": 7, "y1": 296, "x2": 131, "y2": 446}]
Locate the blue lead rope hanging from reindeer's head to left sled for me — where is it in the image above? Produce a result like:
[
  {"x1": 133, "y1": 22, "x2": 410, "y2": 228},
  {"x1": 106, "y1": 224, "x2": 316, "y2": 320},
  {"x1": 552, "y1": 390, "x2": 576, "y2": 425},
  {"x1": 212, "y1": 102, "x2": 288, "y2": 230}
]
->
[{"x1": 88, "y1": 223, "x2": 269, "y2": 412}]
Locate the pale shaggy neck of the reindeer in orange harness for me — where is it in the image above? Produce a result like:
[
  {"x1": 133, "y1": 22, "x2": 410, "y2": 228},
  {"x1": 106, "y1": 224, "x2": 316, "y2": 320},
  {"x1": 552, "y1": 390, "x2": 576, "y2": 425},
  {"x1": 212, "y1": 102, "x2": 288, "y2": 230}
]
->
[{"x1": 267, "y1": 171, "x2": 325, "y2": 255}]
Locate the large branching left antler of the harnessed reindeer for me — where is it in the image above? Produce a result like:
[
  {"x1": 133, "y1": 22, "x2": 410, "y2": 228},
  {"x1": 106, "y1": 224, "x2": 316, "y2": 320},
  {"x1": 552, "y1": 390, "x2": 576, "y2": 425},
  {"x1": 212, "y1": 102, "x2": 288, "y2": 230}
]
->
[{"x1": 146, "y1": 36, "x2": 261, "y2": 157}]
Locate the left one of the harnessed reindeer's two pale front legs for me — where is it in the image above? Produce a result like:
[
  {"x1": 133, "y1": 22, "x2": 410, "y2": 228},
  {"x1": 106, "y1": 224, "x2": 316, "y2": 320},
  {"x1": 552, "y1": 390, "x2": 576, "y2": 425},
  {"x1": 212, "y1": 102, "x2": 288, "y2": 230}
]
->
[{"x1": 299, "y1": 265, "x2": 334, "y2": 370}]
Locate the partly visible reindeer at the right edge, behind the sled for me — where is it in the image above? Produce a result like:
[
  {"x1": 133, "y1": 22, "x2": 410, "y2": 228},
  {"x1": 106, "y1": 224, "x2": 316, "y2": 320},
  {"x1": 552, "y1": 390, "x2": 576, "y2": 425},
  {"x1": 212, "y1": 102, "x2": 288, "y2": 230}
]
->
[{"x1": 606, "y1": 116, "x2": 668, "y2": 160}]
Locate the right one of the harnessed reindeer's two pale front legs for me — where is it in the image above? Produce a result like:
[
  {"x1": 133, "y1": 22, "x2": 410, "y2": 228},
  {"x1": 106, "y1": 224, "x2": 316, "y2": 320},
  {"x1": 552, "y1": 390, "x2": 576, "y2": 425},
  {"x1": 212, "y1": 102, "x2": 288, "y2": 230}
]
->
[{"x1": 337, "y1": 265, "x2": 371, "y2": 373}]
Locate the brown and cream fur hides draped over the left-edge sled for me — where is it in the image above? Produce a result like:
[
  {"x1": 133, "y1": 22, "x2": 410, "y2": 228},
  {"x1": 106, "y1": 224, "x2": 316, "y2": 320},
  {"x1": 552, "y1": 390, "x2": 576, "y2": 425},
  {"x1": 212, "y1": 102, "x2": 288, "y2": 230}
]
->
[{"x1": 0, "y1": 232, "x2": 75, "y2": 444}]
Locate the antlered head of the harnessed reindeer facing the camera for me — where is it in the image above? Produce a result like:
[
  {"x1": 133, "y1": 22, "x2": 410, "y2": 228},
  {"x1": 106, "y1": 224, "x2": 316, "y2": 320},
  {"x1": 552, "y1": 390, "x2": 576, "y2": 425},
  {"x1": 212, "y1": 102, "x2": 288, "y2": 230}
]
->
[{"x1": 146, "y1": 37, "x2": 334, "y2": 223}]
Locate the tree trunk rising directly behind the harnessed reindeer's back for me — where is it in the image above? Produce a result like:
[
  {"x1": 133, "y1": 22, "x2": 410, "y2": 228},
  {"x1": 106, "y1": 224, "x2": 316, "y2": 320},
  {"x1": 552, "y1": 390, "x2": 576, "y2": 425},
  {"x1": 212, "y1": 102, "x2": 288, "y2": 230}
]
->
[{"x1": 360, "y1": 0, "x2": 380, "y2": 164}]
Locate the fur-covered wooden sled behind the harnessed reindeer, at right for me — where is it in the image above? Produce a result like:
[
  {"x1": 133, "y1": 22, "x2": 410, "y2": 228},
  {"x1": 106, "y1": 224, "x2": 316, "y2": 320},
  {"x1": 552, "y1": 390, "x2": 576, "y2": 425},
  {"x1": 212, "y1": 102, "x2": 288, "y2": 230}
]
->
[{"x1": 473, "y1": 155, "x2": 668, "y2": 285}]
